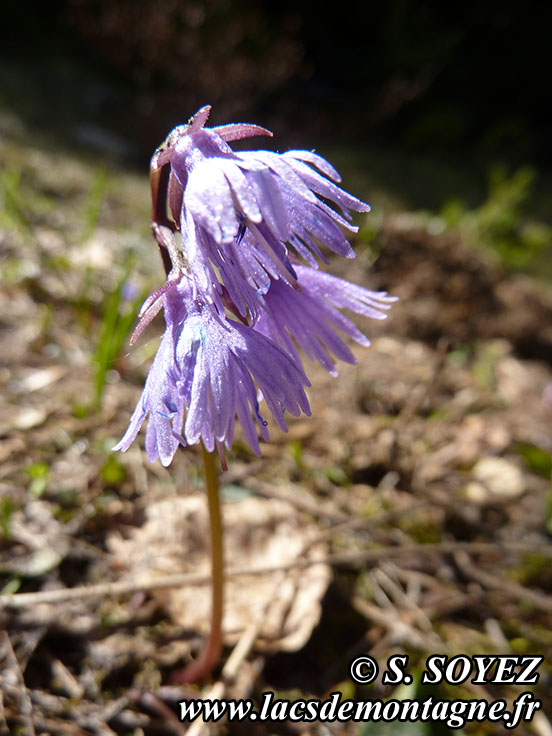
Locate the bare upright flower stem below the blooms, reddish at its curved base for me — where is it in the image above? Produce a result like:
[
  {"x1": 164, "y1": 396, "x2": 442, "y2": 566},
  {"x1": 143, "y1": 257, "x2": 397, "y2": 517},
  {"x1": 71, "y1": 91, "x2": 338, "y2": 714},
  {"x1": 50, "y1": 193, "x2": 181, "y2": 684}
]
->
[{"x1": 173, "y1": 443, "x2": 224, "y2": 684}]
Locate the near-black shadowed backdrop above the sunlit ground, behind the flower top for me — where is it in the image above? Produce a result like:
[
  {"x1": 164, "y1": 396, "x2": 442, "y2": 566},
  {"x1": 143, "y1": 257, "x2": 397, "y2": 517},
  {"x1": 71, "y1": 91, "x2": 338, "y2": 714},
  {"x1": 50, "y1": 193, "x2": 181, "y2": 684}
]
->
[{"x1": 2, "y1": 0, "x2": 552, "y2": 166}]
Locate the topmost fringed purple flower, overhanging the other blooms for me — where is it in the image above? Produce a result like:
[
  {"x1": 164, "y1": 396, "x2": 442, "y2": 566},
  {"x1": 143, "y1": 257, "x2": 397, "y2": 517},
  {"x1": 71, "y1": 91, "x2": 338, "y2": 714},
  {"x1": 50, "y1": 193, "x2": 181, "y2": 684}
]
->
[{"x1": 152, "y1": 106, "x2": 370, "y2": 316}]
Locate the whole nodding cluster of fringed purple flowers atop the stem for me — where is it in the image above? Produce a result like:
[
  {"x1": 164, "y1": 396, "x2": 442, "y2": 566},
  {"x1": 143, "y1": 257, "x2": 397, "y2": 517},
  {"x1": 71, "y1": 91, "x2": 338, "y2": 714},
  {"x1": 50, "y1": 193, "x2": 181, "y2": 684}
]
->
[{"x1": 115, "y1": 107, "x2": 394, "y2": 465}]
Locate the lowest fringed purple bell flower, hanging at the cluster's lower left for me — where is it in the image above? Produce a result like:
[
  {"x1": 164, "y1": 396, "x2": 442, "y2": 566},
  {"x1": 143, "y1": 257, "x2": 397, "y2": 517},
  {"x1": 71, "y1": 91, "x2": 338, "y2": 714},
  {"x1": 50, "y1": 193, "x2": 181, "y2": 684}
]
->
[{"x1": 114, "y1": 277, "x2": 310, "y2": 466}]
